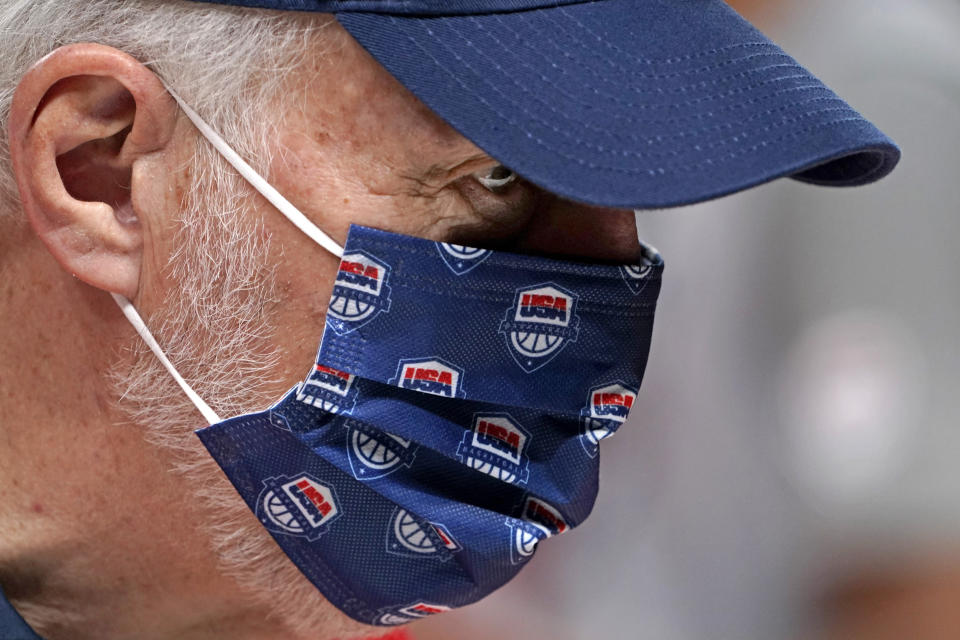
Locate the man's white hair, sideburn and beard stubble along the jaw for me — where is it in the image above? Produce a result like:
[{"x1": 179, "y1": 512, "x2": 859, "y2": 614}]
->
[{"x1": 0, "y1": 0, "x2": 369, "y2": 638}]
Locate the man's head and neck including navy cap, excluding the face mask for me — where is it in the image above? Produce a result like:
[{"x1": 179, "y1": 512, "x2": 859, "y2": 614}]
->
[{"x1": 0, "y1": 0, "x2": 899, "y2": 640}]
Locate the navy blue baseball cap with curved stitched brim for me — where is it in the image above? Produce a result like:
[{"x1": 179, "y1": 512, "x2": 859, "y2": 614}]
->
[{"x1": 189, "y1": 0, "x2": 900, "y2": 208}]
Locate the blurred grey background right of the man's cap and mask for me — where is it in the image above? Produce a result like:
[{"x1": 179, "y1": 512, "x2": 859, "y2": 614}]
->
[{"x1": 413, "y1": 0, "x2": 960, "y2": 640}]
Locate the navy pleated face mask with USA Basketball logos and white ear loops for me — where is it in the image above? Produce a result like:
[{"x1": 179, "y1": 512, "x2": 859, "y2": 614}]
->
[{"x1": 110, "y1": 87, "x2": 663, "y2": 626}]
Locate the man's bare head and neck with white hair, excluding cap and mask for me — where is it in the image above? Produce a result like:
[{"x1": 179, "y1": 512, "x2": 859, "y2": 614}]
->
[{"x1": 0, "y1": 0, "x2": 636, "y2": 639}]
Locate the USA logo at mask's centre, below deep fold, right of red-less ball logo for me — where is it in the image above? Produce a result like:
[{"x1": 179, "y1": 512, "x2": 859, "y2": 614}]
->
[{"x1": 457, "y1": 413, "x2": 530, "y2": 484}]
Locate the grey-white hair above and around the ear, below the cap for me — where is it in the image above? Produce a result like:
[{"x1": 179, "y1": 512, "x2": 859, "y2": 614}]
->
[{"x1": 0, "y1": 0, "x2": 329, "y2": 219}]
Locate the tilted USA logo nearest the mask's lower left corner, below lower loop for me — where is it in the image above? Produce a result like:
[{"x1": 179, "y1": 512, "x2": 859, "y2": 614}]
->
[{"x1": 257, "y1": 473, "x2": 340, "y2": 541}]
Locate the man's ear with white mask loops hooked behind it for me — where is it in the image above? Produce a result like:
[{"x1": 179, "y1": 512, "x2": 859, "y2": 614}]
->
[{"x1": 9, "y1": 44, "x2": 177, "y2": 299}]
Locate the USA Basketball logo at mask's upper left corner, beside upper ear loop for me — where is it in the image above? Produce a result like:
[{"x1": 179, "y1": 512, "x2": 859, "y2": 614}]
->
[{"x1": 327, "y1": 251, "x2": 390, "y2": 335}]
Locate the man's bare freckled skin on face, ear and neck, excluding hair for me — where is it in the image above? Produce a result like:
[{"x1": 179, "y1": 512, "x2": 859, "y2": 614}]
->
[{"x1": 0, "y1": 20, "x2": 638, "y2": 640}]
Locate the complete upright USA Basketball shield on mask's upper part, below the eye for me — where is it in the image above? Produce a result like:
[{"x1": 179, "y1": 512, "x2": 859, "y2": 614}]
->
[{"x1": 500, "y1": 283, "x2": 580, "y2": 373}]
